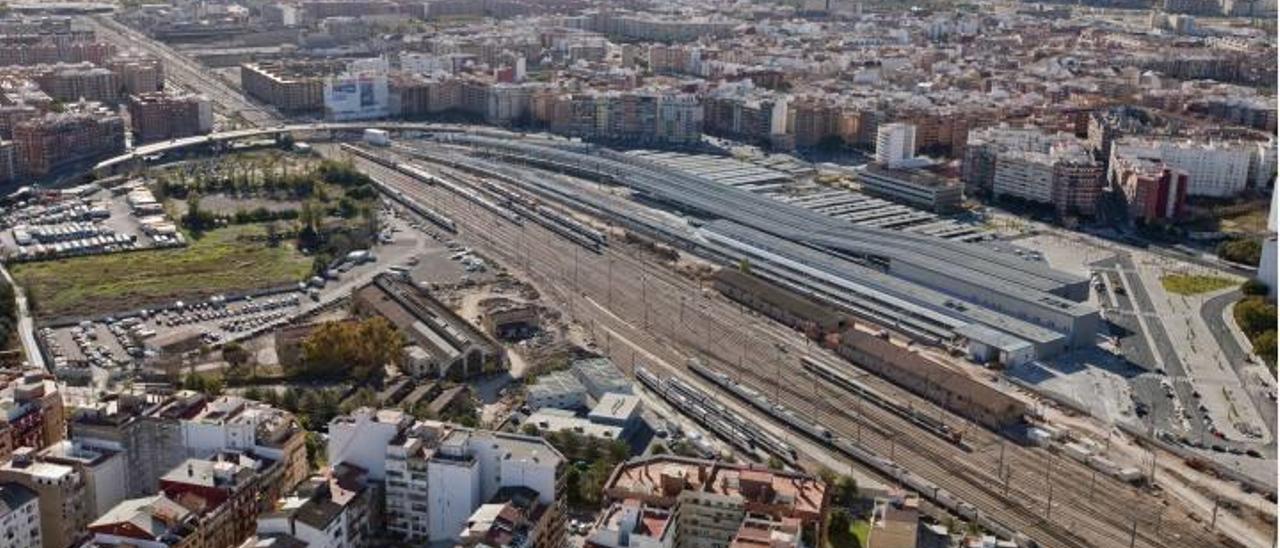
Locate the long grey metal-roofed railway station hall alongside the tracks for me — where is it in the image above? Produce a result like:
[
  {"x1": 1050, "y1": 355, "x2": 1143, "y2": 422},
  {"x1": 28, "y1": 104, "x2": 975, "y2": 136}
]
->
[{"x1": 439, "y1": 134, "x2": 1100, "y2": 357}]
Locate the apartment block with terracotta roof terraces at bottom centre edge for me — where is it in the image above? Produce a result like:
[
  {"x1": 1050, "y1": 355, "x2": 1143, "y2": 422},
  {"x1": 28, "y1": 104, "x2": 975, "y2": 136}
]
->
[{"x1": 586, "y1": 456, "x2": 827, "y2": 548}]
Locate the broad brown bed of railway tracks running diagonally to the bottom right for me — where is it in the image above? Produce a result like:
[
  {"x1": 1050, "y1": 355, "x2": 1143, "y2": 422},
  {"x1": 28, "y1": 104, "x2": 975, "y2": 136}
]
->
[{"x1": 330, "y1": 144, "x2": 1259, "y2": 547}]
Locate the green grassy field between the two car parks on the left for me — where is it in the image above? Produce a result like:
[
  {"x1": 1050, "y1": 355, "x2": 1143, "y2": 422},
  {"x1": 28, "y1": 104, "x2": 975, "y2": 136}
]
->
[{"x1": 13, "y1": 224, "x2": 311, "y2": 318}]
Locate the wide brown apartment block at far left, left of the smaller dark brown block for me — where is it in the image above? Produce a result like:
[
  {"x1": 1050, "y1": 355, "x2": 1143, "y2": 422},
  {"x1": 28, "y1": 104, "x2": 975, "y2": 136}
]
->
[{"x1": 13, "y1": 102, "x2": 124, "y2": 178}]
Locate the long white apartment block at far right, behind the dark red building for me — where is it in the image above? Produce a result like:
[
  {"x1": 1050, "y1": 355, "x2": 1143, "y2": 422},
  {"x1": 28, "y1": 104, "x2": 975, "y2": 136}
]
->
[{"x1": 1111, "y1": 138, "x2": 1260, "y2": 197}]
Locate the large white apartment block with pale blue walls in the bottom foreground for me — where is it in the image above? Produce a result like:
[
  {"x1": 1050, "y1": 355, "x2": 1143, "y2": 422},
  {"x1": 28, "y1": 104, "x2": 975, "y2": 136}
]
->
[{"x1": 328, "y1": 408, "x2": 566, "y2": 545}]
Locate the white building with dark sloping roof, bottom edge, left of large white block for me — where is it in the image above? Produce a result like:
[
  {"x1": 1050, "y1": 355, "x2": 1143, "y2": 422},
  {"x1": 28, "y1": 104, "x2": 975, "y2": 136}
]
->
[{"x1": 250, "y1": 463, "x2": 375, "y2": 548}]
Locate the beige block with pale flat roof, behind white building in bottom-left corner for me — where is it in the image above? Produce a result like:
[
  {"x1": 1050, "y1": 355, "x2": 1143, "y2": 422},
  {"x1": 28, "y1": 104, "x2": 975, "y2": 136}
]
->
[{"x1": 0, "y1": 447, "x2": 91, "y2": 548}]
